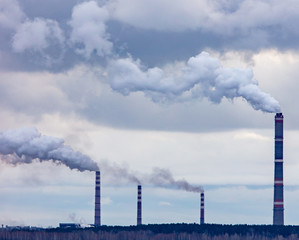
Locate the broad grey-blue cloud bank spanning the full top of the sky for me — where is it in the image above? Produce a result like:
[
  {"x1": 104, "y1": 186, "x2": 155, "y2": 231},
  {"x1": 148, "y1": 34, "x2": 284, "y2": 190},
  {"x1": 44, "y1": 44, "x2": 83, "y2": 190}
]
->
[{"x1": 0, "y1": 0, "x2": 299, "y2": 71}]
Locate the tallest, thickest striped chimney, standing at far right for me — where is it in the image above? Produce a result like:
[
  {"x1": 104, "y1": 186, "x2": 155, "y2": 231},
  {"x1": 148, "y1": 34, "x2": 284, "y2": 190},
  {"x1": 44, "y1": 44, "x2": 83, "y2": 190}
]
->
[{"x1": 273, "y1": 113, "x2": 284, "y2": 225}]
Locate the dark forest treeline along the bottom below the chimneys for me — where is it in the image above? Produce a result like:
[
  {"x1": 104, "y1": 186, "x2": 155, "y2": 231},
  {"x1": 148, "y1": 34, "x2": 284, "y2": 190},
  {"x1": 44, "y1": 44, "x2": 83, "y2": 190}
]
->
[{"x1": 0, "y1": 224, "x2": 299, "y2": 240}]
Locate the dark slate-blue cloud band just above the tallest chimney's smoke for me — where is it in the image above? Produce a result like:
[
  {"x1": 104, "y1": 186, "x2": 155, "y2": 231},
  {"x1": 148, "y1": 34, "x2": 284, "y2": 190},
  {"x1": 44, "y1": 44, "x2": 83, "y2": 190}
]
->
[{"x1": 108, "y1": 21, "x2": 299, "y2": 67}]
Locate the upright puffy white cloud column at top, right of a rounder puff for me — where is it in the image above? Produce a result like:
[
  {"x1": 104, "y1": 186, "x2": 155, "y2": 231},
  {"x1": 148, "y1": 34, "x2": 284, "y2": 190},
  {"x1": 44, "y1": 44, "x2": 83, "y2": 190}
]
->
[{"x1": 69, "y1": 1, "x2": 113, "y2": 58}]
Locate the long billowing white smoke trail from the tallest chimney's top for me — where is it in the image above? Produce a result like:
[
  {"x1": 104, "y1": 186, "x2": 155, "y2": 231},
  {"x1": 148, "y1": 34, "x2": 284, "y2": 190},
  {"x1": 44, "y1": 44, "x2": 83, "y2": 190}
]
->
[{"x1": 107, "y1": 52, "x2": 280, "y2": 112}]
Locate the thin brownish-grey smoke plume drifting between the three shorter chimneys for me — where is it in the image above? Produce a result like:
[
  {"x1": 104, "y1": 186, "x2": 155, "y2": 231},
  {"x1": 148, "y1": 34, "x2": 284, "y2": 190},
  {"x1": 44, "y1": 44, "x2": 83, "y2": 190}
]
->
[{"x1": 100, "y1": 161, "x2": 203, "y2": 192}]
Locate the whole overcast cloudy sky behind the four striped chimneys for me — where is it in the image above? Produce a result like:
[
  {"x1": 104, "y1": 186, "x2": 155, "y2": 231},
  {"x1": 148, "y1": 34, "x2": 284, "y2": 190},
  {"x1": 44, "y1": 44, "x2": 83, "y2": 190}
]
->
[{"x1": 0, "y1": 0, "x2": 299, "y2": 227}]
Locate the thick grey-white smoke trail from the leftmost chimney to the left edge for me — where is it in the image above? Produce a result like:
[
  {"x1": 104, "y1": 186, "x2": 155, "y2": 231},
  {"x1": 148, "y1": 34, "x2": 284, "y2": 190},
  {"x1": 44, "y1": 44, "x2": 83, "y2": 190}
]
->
[{"x1": 0, "y1": 128, "x2": 99, "y2": 171}]
